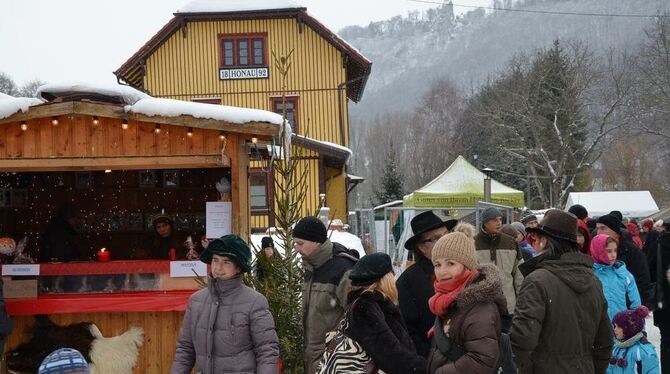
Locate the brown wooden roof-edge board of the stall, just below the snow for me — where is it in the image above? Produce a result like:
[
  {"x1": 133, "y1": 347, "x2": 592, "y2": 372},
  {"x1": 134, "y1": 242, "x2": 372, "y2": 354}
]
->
[{"x1": 0, "y1": 101, "x2": 279, "y2": 136}]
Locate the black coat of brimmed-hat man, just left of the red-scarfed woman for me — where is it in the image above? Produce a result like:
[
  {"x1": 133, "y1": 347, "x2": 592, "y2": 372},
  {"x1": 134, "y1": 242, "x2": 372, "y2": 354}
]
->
[{"x1": 396, "y1": 256, "x2": 435, "y2": 357}]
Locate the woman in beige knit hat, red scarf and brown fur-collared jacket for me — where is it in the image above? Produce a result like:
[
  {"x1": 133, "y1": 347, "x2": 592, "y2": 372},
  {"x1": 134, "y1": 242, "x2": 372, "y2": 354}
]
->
[{"x1": 428, "y1": 224, "x2": 507, "y2": 374}]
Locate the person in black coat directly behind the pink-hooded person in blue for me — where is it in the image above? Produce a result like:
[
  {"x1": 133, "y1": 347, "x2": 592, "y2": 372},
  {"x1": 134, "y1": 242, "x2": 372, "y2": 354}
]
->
[{"x1": 596, "y1": 213, "x2": 653, "y2": 308}]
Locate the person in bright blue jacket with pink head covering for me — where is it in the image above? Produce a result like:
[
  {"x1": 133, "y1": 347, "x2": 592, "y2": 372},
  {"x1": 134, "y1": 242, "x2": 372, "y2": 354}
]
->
[{"x1": 591, "y1": 234, "x2": 642, "y2": 320}]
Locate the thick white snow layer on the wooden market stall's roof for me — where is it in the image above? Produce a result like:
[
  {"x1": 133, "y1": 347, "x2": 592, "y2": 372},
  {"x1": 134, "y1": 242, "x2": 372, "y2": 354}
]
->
[{"x1": 32, "y1": 82, "x2": 283, "y2": 125}]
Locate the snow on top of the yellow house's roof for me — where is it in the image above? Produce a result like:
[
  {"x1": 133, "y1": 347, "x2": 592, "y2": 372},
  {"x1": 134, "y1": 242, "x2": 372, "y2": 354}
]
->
[{"x1": 175, "y1": 0, "x2": 303, "y2": 14}]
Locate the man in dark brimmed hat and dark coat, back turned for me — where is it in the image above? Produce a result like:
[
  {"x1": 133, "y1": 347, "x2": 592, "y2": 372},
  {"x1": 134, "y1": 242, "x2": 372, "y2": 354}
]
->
[{"x1": 511, "y1": 209, "x2": 614, "y2": 374}]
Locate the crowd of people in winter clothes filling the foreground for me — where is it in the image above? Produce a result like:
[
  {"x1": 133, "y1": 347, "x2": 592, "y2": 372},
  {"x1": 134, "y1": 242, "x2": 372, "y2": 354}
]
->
[{"x1": 19, "y1": 206, "x2": 670, "y2": 374}]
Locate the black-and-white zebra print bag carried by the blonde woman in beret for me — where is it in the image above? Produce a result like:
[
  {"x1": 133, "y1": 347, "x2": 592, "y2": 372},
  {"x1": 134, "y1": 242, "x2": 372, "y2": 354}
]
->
[{"x1": 317, "y1": 301, "x2": 384, "y2": 374}]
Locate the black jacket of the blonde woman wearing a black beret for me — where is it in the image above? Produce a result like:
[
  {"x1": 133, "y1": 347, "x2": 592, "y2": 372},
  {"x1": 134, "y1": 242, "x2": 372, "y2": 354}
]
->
[{"x1": 345, "y1": 290, "x2": 426, "y2": 374}]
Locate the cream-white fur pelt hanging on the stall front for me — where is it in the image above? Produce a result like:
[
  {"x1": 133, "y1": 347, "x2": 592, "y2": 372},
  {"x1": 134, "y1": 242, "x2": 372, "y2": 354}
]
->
[{"x1": 90, "y1": 325, "x2": 144, "y2": 374}]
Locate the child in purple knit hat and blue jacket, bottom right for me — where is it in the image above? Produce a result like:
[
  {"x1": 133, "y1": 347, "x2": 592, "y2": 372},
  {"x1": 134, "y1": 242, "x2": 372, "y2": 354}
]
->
[{"x1": 607, "y1": 305, "x2": 661, "y2": 374}]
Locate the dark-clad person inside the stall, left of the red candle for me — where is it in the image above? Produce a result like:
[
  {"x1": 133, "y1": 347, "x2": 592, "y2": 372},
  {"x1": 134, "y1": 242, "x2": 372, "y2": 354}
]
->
[{"x1": 39, "y1": 203, "x2": 80, "y2": 263}]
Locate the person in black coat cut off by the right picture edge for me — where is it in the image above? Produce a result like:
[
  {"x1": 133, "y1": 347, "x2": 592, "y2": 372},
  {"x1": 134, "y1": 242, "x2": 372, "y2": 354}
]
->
[{"x1": 644, "y1": 232, "x2": 670, "y2": 373}]
